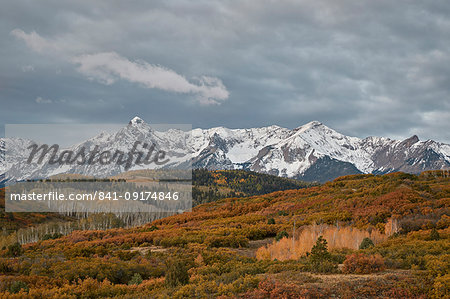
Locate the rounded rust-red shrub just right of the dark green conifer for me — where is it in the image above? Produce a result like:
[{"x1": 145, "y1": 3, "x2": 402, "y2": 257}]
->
[{"x1": 343, "y1": 253, "x2": 384, "y2": 274}]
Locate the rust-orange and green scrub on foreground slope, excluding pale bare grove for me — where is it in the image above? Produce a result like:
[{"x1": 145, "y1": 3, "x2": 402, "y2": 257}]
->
[{"x1": 0, "y1": 172, "x2": 450, "y2": 298}]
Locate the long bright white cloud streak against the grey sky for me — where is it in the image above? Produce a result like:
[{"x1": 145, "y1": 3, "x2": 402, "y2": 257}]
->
[{"x1": 11, "y1": 29, "x2": 229, "y2": 104}]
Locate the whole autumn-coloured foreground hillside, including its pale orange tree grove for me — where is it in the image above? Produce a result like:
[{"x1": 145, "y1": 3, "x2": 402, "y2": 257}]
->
[{"x1": 0, "y1": 171, "x2": 450, "y2": 298}]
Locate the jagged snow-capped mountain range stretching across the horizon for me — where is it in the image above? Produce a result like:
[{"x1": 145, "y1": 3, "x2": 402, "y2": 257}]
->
[{"x1": 0, "y1": 117, "x2": 450, "y2": 182}]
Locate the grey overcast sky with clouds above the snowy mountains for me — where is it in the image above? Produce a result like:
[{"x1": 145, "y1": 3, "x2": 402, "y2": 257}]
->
[{"x1": 0, "y1": 0, "x2": 450, "y2": 143}]
